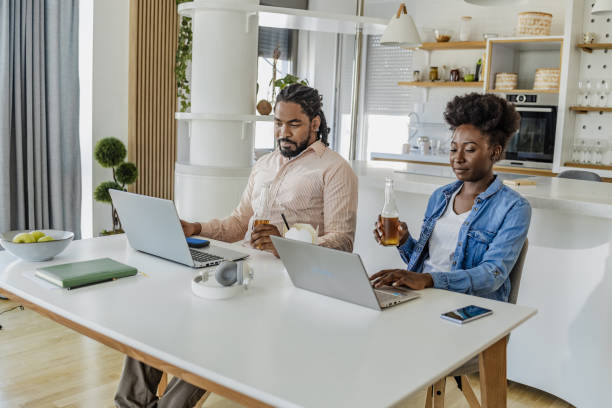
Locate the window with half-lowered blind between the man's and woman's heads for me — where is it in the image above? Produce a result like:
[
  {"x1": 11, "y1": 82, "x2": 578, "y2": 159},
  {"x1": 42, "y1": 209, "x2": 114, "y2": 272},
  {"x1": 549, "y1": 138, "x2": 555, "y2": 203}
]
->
[{"x1": 363, "y1": 35, "x2": 417, "y2": 160}]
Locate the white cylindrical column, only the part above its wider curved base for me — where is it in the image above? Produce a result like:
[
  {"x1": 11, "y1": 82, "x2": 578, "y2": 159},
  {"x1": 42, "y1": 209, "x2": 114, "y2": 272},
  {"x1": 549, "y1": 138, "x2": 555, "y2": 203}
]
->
[{"x1": 190, "y1": 0, "x2": 258, "y2": 167}]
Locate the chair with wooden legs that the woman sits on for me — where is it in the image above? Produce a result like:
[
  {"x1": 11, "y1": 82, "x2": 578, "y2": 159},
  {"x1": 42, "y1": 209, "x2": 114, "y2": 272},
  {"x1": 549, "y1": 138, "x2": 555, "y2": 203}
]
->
[{"x1": 425, "y1": 239, "x2": 529, "y2": 408}]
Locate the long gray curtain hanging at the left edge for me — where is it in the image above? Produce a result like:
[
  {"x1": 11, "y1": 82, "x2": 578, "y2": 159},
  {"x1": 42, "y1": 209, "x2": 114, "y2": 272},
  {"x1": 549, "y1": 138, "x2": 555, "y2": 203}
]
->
[{"x1": 0, "y1": 0, "x2": 81, "y2": 237}]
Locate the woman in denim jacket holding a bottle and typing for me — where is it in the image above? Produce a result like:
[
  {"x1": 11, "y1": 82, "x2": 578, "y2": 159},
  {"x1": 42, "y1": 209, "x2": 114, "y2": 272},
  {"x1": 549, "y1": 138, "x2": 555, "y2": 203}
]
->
[{"x1": 370, "y1": 93, "x2": 531, "y2": 301}]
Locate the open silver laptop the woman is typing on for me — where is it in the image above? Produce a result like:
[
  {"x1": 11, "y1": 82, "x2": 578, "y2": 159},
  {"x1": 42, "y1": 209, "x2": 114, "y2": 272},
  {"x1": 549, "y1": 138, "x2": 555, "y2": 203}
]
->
[{"x1": 270, "y1": 236, "x2": 420, "y2": 310}]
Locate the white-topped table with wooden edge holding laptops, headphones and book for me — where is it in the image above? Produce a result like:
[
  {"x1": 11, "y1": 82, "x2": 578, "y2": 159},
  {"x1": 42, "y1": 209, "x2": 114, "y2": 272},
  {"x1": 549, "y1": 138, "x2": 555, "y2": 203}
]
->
[{"x1": 0, "y1": 236, "x2": 535, "y2": 408}]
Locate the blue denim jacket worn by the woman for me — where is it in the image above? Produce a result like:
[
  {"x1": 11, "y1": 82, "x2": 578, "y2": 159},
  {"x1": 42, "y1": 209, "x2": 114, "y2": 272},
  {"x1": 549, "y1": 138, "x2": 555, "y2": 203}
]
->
[{"x1": 398, "y1": 177, "x2": 531, "y2": 302}]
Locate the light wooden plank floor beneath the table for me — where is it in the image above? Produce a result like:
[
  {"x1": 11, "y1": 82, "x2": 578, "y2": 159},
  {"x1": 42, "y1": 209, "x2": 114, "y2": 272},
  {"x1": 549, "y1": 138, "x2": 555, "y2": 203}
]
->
[{"x1": 0, "y1": 301, "x2": 572, "y2": 408}]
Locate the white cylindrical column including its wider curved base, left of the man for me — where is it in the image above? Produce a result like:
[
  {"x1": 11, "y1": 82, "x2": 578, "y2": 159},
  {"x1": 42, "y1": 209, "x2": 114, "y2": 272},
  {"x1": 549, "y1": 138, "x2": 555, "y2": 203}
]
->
[{"x1": 175, "y1": 0, "x2": 259, "y2": 221}]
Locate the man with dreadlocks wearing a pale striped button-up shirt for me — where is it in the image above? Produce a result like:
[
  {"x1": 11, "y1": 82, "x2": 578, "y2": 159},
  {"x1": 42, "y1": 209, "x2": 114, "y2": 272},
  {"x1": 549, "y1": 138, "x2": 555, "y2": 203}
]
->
[{"x1": 115, "y1": 84, "x2": 357, "y2": 407}]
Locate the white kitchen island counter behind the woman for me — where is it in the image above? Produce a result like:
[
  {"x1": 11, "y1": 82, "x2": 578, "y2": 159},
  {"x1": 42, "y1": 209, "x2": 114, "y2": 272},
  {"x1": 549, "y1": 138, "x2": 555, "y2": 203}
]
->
[{"x1": 353, "y1": 162, "x2": 612, "y2": 407}]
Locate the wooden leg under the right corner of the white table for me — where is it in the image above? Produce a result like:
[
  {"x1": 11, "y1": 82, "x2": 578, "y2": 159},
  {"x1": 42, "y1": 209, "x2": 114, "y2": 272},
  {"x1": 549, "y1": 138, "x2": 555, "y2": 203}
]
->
[{"x1": 479, "y1": 337, "x2": 508, "y2": 408}]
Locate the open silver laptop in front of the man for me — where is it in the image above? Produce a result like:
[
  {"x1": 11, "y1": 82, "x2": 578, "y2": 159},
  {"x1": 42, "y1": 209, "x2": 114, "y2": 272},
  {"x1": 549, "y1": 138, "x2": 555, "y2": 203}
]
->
[{"x1": 109, "y1": 190, "x2": 248, "y2": 268}]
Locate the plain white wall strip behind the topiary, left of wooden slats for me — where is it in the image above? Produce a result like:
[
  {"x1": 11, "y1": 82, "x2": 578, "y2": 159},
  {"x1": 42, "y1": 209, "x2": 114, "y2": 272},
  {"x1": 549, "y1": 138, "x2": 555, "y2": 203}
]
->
[{"x1": 89, "y1": 0, "x2": 130, "y2": 236}]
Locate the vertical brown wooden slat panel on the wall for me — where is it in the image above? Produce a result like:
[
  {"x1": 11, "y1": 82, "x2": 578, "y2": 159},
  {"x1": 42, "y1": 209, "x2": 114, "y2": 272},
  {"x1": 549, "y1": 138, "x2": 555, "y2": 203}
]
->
[{"x1": 128, "y1": 0, "x2": 179, "y2": 199}]
